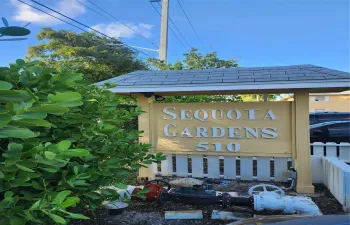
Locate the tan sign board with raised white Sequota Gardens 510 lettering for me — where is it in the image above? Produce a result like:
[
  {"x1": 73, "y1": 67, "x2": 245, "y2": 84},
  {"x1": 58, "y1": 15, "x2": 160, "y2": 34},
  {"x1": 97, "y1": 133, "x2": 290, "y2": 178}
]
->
[{"x1": 154, "y1": 102, "x2": 292, "y2": 156}]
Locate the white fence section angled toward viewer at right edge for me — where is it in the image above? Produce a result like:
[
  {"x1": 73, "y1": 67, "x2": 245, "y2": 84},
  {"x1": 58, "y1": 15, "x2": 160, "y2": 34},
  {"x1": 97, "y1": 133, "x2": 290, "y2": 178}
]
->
[{"x1": 319, "y1": 157, "x2": 350, "y2": 212}]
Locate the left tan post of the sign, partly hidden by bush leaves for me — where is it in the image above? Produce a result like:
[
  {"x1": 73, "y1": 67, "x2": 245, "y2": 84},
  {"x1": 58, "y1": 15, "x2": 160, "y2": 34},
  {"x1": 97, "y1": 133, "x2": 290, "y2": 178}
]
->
[{"x1": 137, "y1": 95, "x2": 153, "y2": 178}]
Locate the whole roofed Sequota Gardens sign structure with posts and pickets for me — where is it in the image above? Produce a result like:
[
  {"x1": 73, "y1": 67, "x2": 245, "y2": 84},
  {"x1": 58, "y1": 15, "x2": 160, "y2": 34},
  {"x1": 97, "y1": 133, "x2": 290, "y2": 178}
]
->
[{"x1": 98, "y1": 65, "x2": 350, "y2": 193}]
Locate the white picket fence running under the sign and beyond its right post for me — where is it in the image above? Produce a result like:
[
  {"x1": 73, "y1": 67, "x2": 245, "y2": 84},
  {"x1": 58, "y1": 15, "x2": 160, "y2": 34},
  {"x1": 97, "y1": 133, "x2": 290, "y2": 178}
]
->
[{"x1": 156, "y1": 142, "x2": 350, "y2": 183}]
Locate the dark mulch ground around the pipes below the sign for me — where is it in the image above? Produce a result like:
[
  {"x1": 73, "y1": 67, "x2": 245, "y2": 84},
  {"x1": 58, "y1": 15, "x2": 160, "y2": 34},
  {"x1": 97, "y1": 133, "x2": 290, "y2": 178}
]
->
[{"x1": 71, "y1": 181, "x2": 344, "y2": 225}]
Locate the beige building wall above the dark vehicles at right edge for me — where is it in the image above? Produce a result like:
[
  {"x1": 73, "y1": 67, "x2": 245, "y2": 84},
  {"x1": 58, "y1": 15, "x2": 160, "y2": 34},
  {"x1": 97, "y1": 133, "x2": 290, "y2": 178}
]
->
[{"x1": 310, "y1": 93, "x2": 350, "y2": 112}]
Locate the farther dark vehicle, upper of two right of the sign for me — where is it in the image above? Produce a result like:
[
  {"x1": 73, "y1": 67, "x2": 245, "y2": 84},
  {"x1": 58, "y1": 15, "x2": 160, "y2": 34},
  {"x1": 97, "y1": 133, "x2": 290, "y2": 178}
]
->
[{"x1": 310, "y1": 112, "x2": 350, "y2": 125}]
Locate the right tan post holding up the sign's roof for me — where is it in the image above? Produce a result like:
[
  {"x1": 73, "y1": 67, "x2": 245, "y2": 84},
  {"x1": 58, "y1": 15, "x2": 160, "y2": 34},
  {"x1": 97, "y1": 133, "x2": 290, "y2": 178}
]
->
[{"x1": 294, "y1": 91, "x2": 314, "y2": 194}]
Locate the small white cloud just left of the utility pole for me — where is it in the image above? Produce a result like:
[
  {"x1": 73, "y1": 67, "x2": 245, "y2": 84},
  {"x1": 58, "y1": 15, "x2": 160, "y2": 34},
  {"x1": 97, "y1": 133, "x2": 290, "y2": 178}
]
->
[{"x1": 92, "y1": 23, "x2": 153, "y2": 38}]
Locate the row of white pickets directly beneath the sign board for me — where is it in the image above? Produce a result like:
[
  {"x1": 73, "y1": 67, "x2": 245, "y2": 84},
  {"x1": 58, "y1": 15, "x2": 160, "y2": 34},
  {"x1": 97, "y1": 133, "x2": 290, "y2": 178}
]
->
[{"x1": 157, "y1": 155, "x2": 292, "y2": 181}]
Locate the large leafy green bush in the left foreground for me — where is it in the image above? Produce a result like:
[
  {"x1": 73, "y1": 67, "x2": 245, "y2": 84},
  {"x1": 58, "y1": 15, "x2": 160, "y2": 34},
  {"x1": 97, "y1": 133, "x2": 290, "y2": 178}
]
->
[{"x1": 0, "y1": 60, "x2": 164, "y2": 225}]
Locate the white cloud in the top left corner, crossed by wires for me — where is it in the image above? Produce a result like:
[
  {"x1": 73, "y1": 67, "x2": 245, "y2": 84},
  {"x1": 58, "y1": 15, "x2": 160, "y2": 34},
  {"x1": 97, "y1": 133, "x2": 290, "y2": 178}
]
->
[{"x1": 10, "y1": 0, "x2": 85, "y2": 25}]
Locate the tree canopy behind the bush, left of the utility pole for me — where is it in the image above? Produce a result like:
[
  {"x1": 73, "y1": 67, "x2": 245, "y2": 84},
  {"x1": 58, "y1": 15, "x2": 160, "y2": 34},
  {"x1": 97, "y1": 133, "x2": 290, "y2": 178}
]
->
[{"x1": 26, "y1": 28, "x2": 147, "y2": 82}]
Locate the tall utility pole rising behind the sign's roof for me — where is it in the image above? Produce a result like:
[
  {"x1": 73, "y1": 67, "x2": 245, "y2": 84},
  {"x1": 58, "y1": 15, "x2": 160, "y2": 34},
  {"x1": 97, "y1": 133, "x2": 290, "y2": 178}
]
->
[{"x1": 159, "y1": 0, "x2": 169, "y2": 63}]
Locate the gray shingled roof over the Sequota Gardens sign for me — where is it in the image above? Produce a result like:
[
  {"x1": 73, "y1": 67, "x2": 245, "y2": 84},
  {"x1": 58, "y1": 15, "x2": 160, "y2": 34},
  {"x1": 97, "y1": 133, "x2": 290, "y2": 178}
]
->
[{"x1": 97, "y1": 65, "x2": 350, "y2": 92}]
